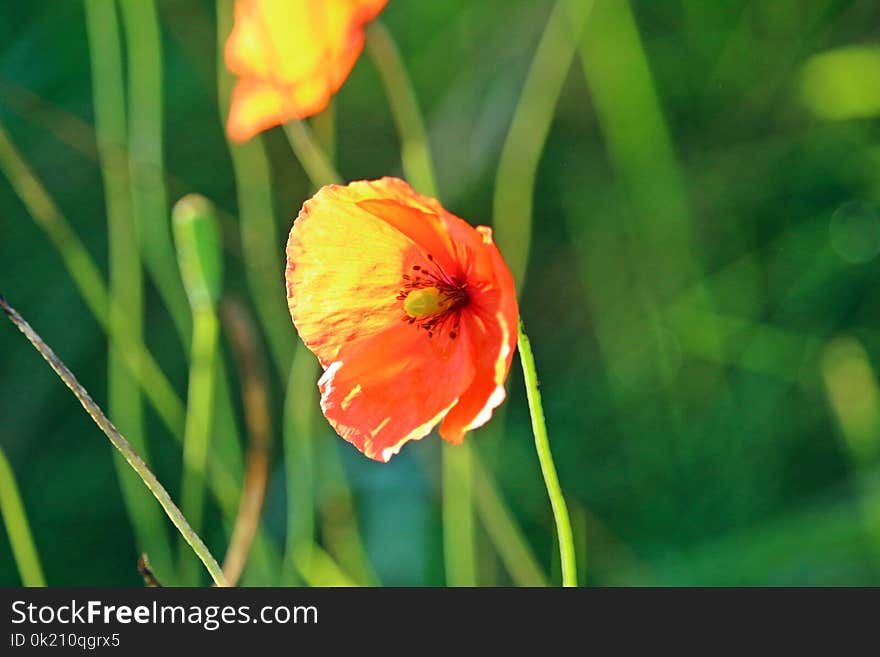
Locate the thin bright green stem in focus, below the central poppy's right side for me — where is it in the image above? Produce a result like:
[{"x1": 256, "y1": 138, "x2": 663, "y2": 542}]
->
[{"x1": 516, "y1": 321, "x2": 577, "y2": 586}]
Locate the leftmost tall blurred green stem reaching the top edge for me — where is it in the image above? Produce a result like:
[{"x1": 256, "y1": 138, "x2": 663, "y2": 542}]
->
[{"x1": 85, "y1": 0, "x2": 172, "y2": 573}]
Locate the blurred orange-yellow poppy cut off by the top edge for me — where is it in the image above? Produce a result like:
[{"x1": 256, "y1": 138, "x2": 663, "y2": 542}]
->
[{"x1": 225, "y1": 0, "x2": 388, "y2": 142}]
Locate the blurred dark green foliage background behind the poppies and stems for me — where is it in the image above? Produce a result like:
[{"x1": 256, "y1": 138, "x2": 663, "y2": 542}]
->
[{"x1": 0, "y1": 0, "x2": 880, "y2": 585}]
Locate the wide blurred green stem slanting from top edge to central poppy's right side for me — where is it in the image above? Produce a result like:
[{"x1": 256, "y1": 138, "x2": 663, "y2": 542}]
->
[{"x1": 492, "y1": 0, "x2": 593, "y2": 290}]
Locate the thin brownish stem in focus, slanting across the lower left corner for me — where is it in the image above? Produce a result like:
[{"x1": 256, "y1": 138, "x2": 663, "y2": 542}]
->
[{"x1": 0, "y1": 297, "x2": 226, "y2": 586}]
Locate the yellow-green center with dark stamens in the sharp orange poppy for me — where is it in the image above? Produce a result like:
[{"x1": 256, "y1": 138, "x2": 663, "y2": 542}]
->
[{"x1": 397, "y1": 255, "x2": 469, "y2": 340}]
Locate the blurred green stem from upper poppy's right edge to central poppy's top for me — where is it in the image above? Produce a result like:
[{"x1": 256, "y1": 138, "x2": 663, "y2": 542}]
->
[{"x1": 366, "y1": 21, "x2": 437, "y2": 196}]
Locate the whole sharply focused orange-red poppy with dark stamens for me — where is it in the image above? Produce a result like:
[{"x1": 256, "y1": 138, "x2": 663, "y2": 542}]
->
[{"x1": 286, "y1": 178, "x2": 519, "y2": 461}]
